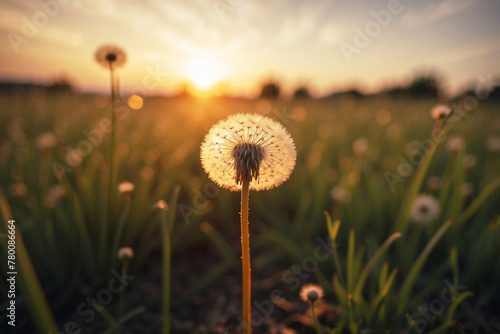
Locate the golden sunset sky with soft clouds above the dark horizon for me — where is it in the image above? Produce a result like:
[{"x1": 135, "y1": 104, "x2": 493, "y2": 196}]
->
[{"x1": 0, "y1": 0, "x2": 500, "y2": 97}]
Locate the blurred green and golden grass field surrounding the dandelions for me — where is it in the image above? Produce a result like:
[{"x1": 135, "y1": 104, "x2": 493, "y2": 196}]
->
[{"x1": 0, "y1": 89, "x2": 500, "y2": 333}]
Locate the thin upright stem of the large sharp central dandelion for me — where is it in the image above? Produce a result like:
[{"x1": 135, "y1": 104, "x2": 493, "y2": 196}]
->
[{"x1": 241, "y1": 177, "x2": 252, "y2": 334}]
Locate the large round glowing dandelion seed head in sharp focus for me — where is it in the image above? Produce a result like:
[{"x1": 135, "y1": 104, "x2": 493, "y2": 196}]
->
[{"x1": 200, "y1": 114, "x2": 297, "y2": 191}]
